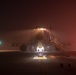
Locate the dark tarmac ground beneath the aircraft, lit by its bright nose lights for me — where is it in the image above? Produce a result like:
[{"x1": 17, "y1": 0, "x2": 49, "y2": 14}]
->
[{"x1": 0, "y1": 52, "x2": 76, "y2": 75}]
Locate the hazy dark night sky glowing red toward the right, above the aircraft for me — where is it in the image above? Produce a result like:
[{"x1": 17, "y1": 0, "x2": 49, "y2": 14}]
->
[{"x1": 0, "y1": 0, "x2": 76, "y2": 49}]
